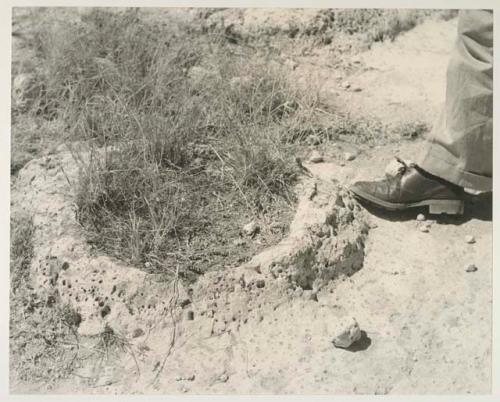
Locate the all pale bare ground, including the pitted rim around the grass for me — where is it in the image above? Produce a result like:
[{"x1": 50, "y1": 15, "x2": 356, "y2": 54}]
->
[{"x1": 11, "y1": 14, "x2": 492, "y2": 394}]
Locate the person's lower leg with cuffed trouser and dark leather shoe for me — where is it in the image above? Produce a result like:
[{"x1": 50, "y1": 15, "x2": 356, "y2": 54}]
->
[{"x1": 350, "y1": 10, "x2": 493, "y2": 214}]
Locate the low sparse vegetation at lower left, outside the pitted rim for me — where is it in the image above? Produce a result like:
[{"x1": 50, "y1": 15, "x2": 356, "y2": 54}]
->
[{"x1": 10, "y1": 215, "x2": 78, "y2": 386}]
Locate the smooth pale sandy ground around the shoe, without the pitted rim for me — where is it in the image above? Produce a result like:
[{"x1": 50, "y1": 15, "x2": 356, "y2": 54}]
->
[{"x1": 9, "y1": 14, "x2": 492, "y2": 394}]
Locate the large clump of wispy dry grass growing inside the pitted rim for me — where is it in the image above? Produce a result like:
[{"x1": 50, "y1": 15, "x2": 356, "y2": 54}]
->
[{"x1": 19, "y1": 9, "x2": 299, "y2": 280}]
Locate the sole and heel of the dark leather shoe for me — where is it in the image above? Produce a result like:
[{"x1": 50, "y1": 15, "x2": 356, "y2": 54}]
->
[{"x1": 351, "y1": 189, "x2": 464, "y2": 215}]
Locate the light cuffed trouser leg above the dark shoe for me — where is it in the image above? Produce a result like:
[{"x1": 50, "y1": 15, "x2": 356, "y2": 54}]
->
[{"x1": 417, "y1": 10, "x2": 493, "y2": 191}]
